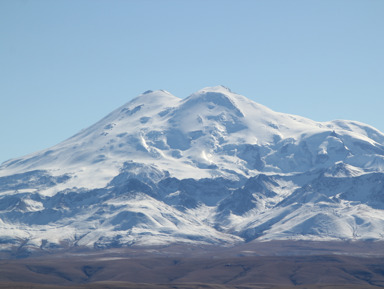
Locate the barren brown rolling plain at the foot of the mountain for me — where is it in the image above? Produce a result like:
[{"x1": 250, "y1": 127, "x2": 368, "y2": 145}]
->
[{"x1": 0, "y1": 241, "x2": 384, "y2": 289}]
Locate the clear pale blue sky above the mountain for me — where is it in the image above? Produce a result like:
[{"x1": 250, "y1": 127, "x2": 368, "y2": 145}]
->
[{"x1": 0, "y1": 0, "x2": 384, "y2": 163}]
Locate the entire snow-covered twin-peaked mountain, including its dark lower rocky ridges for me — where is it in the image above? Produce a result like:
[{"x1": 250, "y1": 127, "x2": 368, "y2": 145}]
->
[{"x1": 0, "y1": 86, "x2": 384, "y2": 250}]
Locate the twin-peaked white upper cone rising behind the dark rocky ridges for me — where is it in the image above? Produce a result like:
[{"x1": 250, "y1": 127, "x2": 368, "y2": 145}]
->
[{"x1": 0, "y1": 86, "x2": 384, "y2": 179}]
